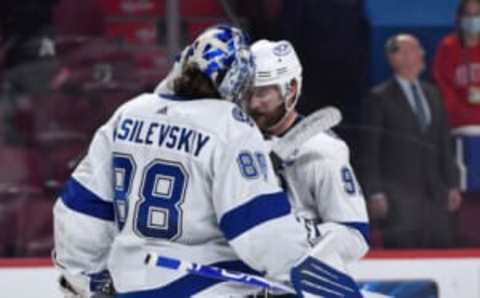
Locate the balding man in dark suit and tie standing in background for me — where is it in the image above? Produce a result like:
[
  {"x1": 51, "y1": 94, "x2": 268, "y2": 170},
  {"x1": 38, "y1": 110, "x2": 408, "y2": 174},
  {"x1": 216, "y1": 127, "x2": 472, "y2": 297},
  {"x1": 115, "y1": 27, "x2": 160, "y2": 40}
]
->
[{"x1": 363, "y1": 34, "x2": 462, "y2": 248}]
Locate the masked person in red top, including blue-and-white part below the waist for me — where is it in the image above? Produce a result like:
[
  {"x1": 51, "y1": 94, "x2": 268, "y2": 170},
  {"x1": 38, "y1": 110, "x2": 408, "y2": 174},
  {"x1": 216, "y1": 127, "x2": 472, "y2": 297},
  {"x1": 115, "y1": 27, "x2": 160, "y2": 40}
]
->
[{"x1": 433, "y1": 0, "x2": 480, "y2": 193}]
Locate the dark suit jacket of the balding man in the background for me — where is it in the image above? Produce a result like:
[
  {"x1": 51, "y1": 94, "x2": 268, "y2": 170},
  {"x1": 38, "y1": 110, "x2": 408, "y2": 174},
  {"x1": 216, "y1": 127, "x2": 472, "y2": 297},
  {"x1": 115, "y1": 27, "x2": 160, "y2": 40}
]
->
[{"x1": 362, "y1": 79, "x2": 458, "y2": 202}]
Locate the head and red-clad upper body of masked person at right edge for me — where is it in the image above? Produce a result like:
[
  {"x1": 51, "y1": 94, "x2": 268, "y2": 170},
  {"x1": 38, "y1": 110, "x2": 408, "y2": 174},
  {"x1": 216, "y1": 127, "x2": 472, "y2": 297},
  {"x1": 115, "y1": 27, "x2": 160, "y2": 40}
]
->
[{"x1": 433, "y1": 0, "x2": 480, "y2": 128}]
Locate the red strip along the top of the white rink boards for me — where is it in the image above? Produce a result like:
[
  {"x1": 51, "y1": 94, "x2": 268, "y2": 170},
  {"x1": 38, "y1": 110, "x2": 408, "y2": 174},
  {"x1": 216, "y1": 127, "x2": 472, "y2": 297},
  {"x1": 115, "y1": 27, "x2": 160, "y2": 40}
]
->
[{"x1": 0, "y1": 249, "x2": 480, "y2": 268}]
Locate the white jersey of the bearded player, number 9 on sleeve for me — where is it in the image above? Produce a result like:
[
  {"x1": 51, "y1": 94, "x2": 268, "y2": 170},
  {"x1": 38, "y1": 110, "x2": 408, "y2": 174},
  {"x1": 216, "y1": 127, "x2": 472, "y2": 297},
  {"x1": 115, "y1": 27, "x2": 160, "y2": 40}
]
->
[{"x1": 272, "y1": 128, "x2": 369, "y2": 264}]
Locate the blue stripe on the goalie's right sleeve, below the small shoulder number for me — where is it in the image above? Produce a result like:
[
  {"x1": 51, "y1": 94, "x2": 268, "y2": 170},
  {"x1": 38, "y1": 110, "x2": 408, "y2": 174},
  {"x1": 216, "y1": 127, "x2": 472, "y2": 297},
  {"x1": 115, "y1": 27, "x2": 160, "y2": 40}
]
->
[{"x1": 220, "y1": 192, "x2": 290, "y2": 240}]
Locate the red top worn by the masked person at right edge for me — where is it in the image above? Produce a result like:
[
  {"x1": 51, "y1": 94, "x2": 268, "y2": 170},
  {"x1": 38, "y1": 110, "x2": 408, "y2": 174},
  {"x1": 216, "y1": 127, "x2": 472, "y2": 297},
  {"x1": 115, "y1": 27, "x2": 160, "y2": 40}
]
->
[{"x1": 433, "y1": 34, "x2": 480, "y2": 127}]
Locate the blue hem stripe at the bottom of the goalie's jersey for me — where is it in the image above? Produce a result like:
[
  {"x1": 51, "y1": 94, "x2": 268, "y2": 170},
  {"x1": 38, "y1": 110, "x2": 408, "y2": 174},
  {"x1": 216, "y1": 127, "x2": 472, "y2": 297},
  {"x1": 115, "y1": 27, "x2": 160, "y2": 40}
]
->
[{"x1": 115, "y1": 261, "x2": 261, "y2": 298}]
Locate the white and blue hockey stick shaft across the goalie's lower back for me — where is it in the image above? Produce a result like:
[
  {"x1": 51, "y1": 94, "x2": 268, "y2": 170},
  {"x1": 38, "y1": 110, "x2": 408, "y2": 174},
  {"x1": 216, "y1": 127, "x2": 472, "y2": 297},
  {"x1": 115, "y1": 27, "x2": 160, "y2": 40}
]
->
[{"x1": 145, "y1": 253, "x2": 295, "y2": 294}]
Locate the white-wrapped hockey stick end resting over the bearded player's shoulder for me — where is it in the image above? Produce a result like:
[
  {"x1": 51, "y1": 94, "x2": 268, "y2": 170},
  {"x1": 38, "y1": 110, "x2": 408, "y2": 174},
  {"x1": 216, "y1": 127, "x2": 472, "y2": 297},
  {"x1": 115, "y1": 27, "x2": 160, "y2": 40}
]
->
[{"x1": 272, "y1": 107, "x2": 342, "y2": 160}]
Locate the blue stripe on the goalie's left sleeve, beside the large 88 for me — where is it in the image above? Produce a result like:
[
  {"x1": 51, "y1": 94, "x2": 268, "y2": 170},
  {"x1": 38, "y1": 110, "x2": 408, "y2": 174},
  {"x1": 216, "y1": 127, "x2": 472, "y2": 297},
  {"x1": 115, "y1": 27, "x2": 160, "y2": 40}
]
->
[{"x1": 61, "y1": 178, "x2": 114, "y2": 221}]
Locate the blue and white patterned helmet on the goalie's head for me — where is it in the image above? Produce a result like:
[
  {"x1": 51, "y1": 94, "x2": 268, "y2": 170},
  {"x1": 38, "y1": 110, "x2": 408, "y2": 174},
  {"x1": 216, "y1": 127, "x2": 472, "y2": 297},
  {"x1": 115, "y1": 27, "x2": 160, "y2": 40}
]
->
[{"x1": 183, "y1": 25, "x2": 255, "y2": 102}]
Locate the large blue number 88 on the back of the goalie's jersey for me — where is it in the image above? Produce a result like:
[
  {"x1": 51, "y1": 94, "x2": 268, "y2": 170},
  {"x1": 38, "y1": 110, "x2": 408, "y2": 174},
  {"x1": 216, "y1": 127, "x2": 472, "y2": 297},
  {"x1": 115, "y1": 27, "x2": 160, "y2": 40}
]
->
[{"x1": 113, "y1": 154, "x2": 188, "y2": 240}]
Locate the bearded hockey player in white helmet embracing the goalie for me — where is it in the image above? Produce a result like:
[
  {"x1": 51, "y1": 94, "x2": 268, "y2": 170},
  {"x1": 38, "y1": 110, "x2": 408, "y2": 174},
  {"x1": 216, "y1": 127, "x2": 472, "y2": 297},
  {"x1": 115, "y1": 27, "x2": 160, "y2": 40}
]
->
[{"x1": 247, "y1": 40, "x2": 368, "y2": 296}]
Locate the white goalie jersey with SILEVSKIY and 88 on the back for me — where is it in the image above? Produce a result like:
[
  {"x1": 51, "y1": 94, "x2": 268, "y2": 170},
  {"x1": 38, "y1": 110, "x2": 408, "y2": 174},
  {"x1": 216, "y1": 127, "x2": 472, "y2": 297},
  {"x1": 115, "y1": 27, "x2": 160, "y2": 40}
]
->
[{"x1": 54, "y1": 94, "x2": 309, "y2": 298}]
